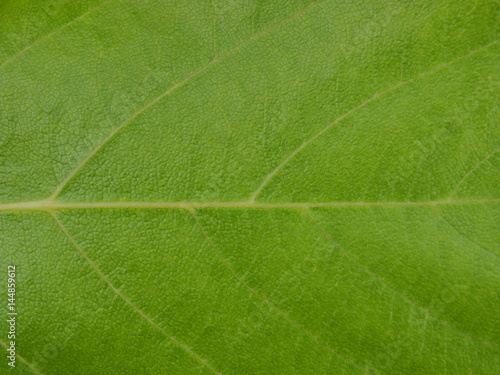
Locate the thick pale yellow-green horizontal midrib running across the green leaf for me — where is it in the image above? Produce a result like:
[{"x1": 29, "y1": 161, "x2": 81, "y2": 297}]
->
[{"x1": 0, "y1": 199, "x2": 500, "y2": 211}]
